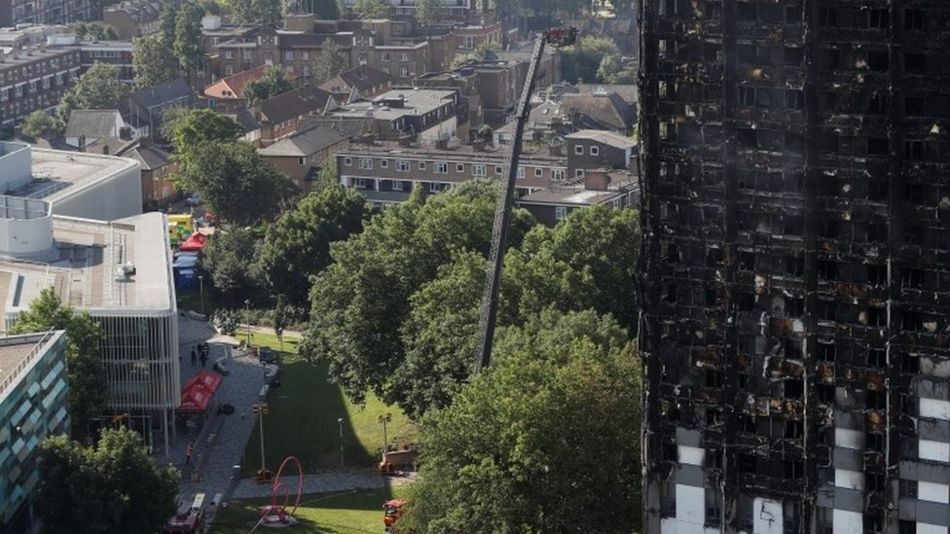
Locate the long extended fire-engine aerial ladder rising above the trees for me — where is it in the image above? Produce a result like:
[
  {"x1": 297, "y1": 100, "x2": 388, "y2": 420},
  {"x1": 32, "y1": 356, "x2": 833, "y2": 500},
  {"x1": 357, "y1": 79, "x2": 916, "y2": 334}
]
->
[{"x1": 475, "y1": 27, "x2": 577, "y2": 372}]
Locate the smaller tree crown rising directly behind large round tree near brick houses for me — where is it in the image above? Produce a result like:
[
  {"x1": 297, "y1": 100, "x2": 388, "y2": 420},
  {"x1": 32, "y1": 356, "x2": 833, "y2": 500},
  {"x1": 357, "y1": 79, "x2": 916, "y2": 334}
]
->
[{"x1": 162, "y1": 107, "x2": 244, "y2": 172}]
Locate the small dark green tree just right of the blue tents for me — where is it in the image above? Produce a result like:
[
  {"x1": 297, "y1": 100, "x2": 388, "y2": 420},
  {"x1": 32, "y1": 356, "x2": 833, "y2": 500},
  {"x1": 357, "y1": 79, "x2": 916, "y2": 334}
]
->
[{"x1": 199, "y1": 226, "x2": 258, "y2": 306}]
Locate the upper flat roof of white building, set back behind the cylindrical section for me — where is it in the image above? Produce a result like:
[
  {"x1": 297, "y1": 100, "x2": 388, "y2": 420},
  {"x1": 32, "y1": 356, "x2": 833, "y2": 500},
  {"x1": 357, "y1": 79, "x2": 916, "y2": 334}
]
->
[{"x1": 17, "y1": 146, "x2": 139, "y2": 204}]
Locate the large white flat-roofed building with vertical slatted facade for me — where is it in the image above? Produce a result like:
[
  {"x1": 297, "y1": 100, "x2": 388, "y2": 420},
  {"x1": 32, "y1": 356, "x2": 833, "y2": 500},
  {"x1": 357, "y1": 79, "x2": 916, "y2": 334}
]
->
[{"x1": 0, "y1": 143, "x2": 181, "y2": 451}]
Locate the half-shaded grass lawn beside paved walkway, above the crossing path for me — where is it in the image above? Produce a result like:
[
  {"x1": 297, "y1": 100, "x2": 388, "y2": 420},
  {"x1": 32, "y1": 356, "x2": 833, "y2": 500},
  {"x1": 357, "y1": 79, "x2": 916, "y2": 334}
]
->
[{"x1": 244, "y1": 332, "x2": 415, "y2": 476}]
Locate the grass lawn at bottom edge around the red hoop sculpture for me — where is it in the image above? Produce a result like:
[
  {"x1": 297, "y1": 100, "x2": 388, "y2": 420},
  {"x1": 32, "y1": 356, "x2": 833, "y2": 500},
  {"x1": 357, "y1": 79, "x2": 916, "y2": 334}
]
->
[{"x1": 211, "y1": 488, "x2": 402, "y2": 534}]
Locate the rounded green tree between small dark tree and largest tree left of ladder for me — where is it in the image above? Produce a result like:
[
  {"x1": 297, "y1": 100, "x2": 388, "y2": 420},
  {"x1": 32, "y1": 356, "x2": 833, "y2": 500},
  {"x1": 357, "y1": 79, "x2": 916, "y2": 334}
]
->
[{"x1": 259, "y1": 184, "x2": 366, "y2": 307}]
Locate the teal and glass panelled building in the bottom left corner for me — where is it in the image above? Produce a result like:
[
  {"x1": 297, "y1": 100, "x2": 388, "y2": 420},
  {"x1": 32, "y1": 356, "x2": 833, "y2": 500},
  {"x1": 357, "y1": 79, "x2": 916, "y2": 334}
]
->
[{"x1": 0, "y1": 331, "x2": 69, "y2": 534}]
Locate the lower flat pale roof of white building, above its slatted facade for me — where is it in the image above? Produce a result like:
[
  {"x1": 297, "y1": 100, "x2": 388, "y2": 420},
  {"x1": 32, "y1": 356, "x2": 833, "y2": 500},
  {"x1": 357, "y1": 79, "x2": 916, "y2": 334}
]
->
[{"x1": 0, "y1": 212, "x2": 175, "y2": 322}]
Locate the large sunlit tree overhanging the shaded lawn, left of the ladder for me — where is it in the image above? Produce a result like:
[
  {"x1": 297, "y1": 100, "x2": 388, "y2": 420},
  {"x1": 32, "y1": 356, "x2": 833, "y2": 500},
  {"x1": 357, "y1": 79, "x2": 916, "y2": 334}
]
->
[{"x1": 302, "y1": 180, "x2": 533, "y2": 400}]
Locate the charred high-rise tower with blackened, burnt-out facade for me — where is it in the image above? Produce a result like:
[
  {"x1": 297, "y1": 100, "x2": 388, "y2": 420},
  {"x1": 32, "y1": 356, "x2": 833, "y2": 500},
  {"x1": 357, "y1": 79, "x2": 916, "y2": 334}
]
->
[{"x1": 638, "y1": 0, "x2": 950, "y2": 534}]
